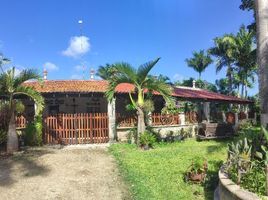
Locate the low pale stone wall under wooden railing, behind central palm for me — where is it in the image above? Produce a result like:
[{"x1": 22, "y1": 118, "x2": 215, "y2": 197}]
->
[{"x1": 117, "y1": 124, "x2": 198, "y2": 141}]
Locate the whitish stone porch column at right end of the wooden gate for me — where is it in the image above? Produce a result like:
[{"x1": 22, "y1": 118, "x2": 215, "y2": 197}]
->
[{"x1": 107, "y1": 98, "x2": 117, "y2": 141}]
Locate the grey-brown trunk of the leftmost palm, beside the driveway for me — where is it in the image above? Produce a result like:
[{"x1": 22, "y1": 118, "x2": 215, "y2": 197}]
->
[{"x1": 7, "y1": 109, "x2": 19, "y2": 154}]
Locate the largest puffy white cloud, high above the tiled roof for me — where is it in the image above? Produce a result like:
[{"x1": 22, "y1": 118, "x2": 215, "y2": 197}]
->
[{"x1": 62, "y1": 36, "x2": 90, "y2": 58}]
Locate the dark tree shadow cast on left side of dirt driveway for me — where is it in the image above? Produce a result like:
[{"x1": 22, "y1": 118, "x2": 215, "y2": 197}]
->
[{"x1": 0, "y1": 148, "x2": 53, "y2": 187}]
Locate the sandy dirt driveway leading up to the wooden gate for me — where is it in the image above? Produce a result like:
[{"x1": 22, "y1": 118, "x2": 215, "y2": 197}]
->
[{"x1": 0, "y1": 147, "x2": 131, "y2": 200}]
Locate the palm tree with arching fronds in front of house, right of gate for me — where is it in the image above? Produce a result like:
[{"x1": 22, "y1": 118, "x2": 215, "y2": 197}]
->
[{"x1": 103, "y1": 58, "x2": 172, "y2": 145}]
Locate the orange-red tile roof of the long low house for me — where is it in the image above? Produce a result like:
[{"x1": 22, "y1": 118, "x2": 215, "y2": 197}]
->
[{"x1": 24, "y1": 80, "x2": 251, "y2": 103}]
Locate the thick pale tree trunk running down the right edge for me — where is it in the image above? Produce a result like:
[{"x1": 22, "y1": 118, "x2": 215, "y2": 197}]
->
[{"x1": 255, "y1": 0, "x2": 268, "y2": 127}]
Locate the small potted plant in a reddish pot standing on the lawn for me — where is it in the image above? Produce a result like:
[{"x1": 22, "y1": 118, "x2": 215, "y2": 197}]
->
[{"x1": 186, "y1": 157, "x2": 208, "y2": 183}]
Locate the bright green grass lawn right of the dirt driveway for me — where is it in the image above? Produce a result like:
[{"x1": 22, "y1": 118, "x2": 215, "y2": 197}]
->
[{"x1": 110, "y1": 139, "x2": 227, "y2": 200}]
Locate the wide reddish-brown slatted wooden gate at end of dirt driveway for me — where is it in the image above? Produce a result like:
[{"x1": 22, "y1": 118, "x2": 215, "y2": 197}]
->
[{"x1": 43, "y1": 113, "x2": 109, "y2": 144}]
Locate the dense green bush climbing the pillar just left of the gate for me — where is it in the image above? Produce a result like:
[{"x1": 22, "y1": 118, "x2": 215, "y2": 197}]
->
[{"x1": 24, "y1": 116, "x2": 43, "y2": 146}]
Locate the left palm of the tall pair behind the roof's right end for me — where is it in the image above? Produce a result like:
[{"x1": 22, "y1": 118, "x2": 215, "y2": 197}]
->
[{"x1": 209, "y1": 34, "x2": 235, "y2": 95}]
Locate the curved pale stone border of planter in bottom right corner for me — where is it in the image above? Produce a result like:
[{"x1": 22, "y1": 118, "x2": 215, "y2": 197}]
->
[{"x1": 218, "y1": 167, "x2": 261, "y2": 200}]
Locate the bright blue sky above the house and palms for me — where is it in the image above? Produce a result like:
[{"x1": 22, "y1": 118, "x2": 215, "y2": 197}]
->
[{"x1": 0, "y1": 0, "x2": 257, "y2": 94}]
